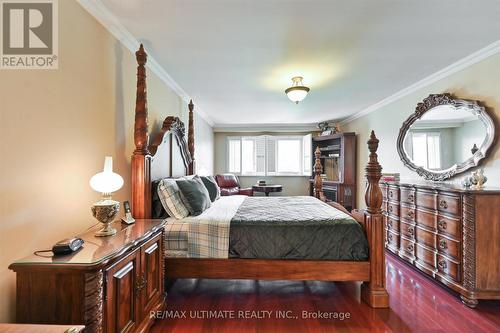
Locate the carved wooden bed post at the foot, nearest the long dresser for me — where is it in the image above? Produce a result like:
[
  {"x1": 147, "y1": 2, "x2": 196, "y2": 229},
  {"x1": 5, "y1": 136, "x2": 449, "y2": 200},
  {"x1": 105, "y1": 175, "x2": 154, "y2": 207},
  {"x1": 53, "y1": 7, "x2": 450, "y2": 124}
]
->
[{"x1": 361, "y1": 131, "x2": 389, "y2": 308}]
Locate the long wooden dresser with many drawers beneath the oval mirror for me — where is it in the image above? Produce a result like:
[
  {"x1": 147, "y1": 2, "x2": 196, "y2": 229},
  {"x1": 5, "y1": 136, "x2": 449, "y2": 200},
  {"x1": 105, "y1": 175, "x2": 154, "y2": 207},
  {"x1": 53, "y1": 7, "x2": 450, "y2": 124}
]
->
[{"x1": 381, "y1": 182, "x2": 500, "y2": 307}]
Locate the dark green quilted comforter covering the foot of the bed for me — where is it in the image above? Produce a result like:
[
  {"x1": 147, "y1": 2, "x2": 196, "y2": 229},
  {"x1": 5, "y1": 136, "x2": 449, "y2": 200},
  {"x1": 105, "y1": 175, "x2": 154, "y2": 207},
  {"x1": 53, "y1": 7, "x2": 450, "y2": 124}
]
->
[{"x1": 229, "y1": 196, "x2": 368, "y2": 260}]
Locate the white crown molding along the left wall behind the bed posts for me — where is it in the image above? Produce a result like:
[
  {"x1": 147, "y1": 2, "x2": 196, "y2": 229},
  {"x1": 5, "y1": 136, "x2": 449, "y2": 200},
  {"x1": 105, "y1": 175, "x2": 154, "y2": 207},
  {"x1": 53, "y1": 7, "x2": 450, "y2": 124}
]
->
[{"x1": 77, "y1": 0, "x2": 214, "y2": 126}]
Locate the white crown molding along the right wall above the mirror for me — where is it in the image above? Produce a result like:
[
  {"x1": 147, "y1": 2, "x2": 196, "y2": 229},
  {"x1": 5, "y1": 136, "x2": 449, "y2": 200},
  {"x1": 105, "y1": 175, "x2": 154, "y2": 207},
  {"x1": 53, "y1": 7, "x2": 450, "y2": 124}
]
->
[{"x1": 339, "y1": 40, "x2": 500, "y2": 125}]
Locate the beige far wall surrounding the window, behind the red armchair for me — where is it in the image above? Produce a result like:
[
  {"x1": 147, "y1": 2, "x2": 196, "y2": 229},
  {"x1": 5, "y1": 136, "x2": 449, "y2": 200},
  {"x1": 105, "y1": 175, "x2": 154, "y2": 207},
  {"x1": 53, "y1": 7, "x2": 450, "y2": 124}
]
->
[{"x1": 214, "y1": 132, "x2": 309, "y2": 196}]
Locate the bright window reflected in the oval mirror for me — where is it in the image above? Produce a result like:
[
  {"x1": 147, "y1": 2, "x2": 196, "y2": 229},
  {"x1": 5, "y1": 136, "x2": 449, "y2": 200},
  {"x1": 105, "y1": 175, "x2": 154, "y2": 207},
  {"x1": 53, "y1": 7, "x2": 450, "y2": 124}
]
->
[{"x1": 411, "y1": 132, "x2": 441, "y2": 170}]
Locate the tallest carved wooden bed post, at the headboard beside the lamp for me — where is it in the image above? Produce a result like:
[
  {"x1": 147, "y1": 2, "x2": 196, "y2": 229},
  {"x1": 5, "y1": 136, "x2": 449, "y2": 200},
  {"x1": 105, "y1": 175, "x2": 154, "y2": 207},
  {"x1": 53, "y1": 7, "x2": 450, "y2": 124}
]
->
[{"x1": 131, "y1": 44, "x2": 151, "y2": 218}]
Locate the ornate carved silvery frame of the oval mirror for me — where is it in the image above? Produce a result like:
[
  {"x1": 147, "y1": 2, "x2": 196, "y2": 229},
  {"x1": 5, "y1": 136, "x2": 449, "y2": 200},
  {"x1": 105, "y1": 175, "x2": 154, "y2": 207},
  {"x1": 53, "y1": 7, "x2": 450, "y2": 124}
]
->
[{"x1": 396, "y1": 93, "x2": 495, "y2": 181}]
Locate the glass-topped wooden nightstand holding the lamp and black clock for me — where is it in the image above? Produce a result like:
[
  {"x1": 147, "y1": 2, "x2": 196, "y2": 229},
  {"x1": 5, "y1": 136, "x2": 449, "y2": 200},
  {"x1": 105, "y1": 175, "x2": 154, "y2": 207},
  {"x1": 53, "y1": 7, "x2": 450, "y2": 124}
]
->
[{"x1": 9, "y1": 220, "x2": 165, "y2": 333}]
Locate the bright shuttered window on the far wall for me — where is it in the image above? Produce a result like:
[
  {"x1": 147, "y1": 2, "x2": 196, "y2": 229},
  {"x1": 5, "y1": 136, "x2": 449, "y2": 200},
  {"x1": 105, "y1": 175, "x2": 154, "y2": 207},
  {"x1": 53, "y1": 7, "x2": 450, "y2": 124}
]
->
[{"x1": 227, "y1": 134, "x2": 311, "y2": 176}]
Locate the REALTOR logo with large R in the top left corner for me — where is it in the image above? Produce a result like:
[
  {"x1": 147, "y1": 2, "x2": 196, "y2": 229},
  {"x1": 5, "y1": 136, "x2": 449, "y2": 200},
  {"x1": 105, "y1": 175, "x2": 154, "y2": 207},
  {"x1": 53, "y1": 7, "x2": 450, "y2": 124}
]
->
[{"x1": 0, "y1": 0, "x2": 58, "y2": 69}]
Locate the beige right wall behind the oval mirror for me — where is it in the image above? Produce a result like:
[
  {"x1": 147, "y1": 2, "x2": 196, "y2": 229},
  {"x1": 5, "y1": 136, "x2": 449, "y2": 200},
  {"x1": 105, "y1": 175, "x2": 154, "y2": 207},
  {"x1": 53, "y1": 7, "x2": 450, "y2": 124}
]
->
[{"x1": 343, "y1": 54, "x2": 500, "y2": 205}]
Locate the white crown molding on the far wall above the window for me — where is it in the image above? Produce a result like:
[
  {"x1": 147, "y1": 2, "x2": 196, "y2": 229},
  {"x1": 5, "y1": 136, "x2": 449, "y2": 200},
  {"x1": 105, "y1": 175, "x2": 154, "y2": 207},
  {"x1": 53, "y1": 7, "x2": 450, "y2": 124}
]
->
[{"x1": 213, "y1": 123, "x2": 319, "y2": 133}]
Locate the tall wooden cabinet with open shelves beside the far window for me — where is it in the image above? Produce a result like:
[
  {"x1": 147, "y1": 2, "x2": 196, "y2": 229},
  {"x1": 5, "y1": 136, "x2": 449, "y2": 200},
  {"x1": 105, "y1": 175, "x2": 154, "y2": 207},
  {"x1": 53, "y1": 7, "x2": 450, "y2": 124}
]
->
[{"x1": 309, "y1": 132, "x2": 356, "y2": 211}]
